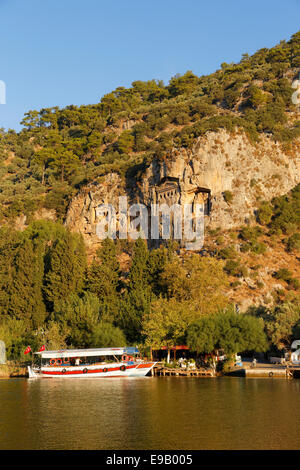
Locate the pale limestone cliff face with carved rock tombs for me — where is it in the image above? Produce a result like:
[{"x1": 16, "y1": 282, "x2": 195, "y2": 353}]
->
[{"x1": 66, "y1": 130, "x2": 300, "y2": 247}]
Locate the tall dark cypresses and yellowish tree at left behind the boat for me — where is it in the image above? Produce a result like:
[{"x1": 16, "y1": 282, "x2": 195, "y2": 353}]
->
[{"x1": 0, "y1": 226, "x2": 226, "y2": 357}]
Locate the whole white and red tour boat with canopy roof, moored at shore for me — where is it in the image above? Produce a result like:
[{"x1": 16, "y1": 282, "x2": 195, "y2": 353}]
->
[{"x1": 28, "y1": 347, "x2": 156, "y2": 378}]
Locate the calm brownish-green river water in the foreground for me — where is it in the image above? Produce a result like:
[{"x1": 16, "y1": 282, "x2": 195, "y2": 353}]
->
[{"x1": 0, "y1": 377, "x2": 300, "y2": 450}]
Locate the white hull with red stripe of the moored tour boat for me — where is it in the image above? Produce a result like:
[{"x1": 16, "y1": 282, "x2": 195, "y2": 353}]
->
[{"x1": 28, "y1": 362, "x2": 156, "y2": 379}]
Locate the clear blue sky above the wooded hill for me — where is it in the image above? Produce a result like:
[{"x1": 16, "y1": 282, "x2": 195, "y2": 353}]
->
[{"x1": 0, "y1": 0, "x2": 300, "y2": 130}]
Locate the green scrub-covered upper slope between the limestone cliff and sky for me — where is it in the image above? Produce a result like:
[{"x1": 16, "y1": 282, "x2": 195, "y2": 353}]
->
[{"x1": 0, "y1": 32, "x2": 300, "y2": 222}]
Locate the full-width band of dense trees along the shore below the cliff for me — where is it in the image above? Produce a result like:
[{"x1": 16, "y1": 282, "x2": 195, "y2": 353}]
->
[{"x1": 0, "y1": 217, "x2": 300, "y2": 358}]
